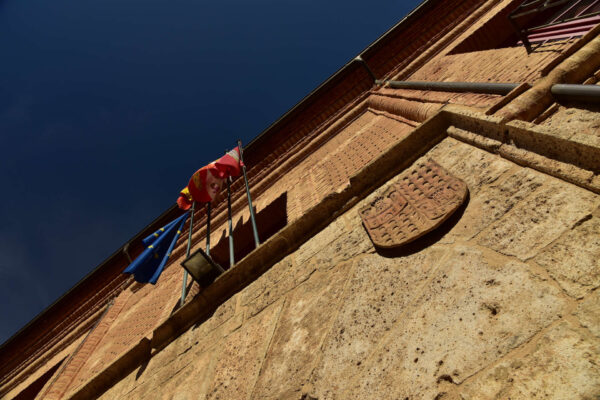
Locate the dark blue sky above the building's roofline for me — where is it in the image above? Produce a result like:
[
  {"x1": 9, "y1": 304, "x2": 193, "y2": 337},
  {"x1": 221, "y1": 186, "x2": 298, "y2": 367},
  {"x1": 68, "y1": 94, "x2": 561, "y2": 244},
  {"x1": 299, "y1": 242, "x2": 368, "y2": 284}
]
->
[{"x1": 0, "y1": 0, "x2": 418, "y2": 343}]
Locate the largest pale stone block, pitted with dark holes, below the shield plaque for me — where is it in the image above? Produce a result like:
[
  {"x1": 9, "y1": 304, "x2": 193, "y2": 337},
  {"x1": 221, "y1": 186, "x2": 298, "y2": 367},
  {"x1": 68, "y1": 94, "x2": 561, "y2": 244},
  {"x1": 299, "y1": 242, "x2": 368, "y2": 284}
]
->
[{"x1": 336, "y1": 246, "x2": 566, "y2": 399}]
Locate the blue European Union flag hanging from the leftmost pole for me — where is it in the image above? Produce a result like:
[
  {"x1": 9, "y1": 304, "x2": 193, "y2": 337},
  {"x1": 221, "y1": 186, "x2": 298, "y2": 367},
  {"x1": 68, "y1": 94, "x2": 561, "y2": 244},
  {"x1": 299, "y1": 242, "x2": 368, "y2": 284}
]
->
[{"x1": 123, "y1": 213, "x2": 188, "y2": 284}]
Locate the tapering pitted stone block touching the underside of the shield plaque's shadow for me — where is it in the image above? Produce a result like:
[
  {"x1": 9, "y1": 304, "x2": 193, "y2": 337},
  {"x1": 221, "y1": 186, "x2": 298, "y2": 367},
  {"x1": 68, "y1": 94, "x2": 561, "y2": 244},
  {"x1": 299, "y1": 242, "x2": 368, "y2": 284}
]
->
[{"x1": 311, "y1": 247, "x2": 444, "y2": 399}]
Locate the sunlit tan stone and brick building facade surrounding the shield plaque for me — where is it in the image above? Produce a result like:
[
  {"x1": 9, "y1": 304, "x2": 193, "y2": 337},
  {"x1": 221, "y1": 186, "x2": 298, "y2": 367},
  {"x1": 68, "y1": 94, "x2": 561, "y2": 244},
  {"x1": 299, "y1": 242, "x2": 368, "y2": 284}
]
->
[{"x1": 0, "y1": 0, "x2": 600, "y2": 400}]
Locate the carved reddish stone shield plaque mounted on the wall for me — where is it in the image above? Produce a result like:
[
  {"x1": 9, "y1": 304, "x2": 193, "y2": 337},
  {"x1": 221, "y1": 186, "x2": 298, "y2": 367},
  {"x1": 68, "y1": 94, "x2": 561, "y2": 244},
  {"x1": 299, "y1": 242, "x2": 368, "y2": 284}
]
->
[{"x1": 359, "y1": 160, "x2": 468, "y2": 248}]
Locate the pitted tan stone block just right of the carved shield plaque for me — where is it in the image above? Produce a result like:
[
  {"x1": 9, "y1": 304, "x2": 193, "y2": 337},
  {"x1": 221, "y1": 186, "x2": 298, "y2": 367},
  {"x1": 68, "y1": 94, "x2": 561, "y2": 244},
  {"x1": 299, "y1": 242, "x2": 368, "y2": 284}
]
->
[{"x1": 479, "y1": 179, "x2": 598, "y2": 260}]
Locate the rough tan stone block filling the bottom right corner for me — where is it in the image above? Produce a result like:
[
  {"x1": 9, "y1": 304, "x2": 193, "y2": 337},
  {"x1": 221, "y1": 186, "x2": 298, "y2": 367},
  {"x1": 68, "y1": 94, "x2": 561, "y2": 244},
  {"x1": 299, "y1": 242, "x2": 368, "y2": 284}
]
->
[{"x1": 461, "y1": 322, "x2": 600, "y2": 400}]
